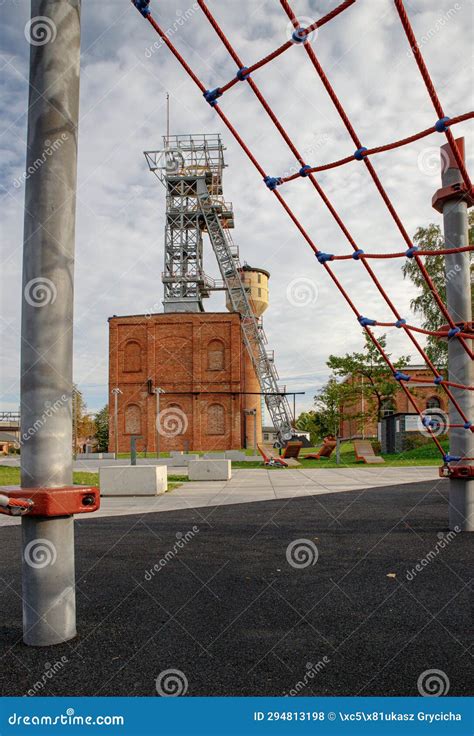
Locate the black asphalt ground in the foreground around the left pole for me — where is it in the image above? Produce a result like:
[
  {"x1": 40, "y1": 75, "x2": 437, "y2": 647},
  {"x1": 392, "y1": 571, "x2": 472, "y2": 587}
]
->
[{"x1": 0, "y1": 481, "x2": 474, "y2": 696}]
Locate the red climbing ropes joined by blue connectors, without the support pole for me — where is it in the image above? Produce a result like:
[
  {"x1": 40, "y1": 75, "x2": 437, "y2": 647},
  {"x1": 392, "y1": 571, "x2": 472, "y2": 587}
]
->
[{"x1": 132, "y1": 0, "x2": 474, "y2": 462}]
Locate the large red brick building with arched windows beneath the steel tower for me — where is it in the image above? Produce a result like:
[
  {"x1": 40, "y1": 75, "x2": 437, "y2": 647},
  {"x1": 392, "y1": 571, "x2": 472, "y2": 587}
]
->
[{"x1": 109, "y1": 312, "x2": 262, "y2": 452}]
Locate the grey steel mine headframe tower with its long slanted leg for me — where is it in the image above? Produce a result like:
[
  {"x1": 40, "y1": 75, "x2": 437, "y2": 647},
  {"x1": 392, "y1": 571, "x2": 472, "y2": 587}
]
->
[{"x1": 145, "y1": 135, "x2": 293, "y2": 443}]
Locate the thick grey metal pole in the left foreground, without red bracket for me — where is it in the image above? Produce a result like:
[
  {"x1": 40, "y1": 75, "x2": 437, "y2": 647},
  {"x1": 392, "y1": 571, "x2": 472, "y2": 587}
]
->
[{"x1": 21, "y1": 0, "x2": 80, "y2": 646}]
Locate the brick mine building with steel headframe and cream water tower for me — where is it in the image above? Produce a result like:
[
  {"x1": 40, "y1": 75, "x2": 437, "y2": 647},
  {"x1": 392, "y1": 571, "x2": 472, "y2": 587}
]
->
[{"x1": 109, "y1": 135, "x2": 293, "y2": 452}]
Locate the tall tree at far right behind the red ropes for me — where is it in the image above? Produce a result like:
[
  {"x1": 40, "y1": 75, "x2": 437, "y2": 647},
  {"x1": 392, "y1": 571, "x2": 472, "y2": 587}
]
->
[{"x1": 402, "y1": 210, "x2": 474, "y2": 371}]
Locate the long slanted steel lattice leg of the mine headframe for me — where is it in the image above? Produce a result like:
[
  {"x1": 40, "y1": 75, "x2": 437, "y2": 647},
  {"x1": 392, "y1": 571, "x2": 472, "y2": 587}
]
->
[{"x1": 196, "y1": 177, "x2": 293, "y2": 443}]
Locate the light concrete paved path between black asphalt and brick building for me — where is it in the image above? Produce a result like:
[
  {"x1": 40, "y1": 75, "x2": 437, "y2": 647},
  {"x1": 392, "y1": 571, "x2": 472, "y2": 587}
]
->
[{"x1": 0, "y1": 460, "x2": 438, "y2": 526}]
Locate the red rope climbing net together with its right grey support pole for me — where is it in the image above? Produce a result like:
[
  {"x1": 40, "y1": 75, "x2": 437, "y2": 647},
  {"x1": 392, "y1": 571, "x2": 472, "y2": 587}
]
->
[{"x1": 132, "y1": 0, "x2": 474, "y2": 531}]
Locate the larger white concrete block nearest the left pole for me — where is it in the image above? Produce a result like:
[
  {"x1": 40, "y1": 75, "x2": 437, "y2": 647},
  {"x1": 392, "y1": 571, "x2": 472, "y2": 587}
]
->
[{"x1": 99, "y1": 465, "x2": 168, "y2": 496}]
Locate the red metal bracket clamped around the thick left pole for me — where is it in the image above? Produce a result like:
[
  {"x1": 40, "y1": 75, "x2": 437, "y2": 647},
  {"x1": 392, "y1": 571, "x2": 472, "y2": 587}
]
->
[{"x1": 5, "y1": 486, "x2": 100, "y2": 516}]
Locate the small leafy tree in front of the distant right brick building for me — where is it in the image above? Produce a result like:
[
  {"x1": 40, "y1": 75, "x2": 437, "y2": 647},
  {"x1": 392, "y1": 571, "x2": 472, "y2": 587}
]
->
[{"x1": 326, "y1": 332, "x2": 410, "y2": 425}]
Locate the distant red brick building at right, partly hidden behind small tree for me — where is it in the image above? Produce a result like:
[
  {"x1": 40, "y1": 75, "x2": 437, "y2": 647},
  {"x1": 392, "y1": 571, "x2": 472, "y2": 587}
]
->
[{"x1": 340, "y1": 365, "x2": 448, "y2": 437}]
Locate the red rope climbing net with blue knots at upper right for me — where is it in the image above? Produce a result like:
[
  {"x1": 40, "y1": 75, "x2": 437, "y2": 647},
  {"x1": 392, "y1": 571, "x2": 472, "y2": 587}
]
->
[{"x1": 132, "y1": 0, "x2": 474, "y2": 464}]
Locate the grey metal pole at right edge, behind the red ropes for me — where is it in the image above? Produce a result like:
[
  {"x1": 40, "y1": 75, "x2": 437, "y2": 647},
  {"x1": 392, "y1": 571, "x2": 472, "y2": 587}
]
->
[{"x1": 441, "y1": 139, "x2": 474, "y2": 531}]
